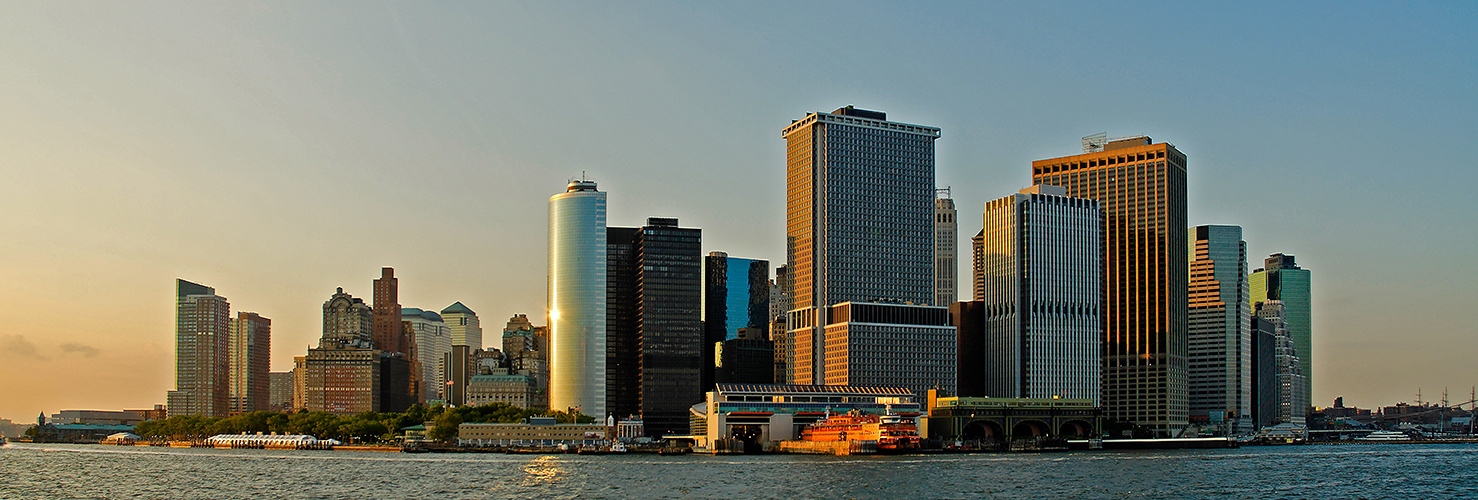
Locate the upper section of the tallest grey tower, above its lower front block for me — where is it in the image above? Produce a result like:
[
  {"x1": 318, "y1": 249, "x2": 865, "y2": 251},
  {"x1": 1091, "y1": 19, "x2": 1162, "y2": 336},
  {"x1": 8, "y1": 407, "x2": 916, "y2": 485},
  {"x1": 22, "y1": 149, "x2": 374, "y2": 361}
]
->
[{"x1": 783, "y1": 107, "x2": 939, "y2": 315}]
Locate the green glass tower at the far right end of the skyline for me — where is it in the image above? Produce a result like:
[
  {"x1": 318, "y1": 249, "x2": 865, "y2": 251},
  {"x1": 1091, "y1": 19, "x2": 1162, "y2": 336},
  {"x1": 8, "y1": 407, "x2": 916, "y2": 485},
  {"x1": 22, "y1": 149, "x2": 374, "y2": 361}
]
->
[{"x1": 1247, "y1": 253, "x2": 1314, "y2": 401}]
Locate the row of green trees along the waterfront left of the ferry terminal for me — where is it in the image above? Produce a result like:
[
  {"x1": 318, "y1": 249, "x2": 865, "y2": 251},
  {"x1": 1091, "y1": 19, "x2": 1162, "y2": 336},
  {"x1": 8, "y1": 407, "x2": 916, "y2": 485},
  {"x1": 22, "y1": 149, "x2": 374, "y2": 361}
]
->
[{"x1": 133, "y1": 402, "x2": 596, "y2": 442}]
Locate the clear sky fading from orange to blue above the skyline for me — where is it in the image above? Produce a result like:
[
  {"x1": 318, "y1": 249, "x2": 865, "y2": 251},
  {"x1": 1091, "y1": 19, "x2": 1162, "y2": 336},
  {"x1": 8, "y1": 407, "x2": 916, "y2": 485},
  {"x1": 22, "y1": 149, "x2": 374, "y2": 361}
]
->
[{"x1": 0, "y1": 1, "x2": 1478, "y2": 420}]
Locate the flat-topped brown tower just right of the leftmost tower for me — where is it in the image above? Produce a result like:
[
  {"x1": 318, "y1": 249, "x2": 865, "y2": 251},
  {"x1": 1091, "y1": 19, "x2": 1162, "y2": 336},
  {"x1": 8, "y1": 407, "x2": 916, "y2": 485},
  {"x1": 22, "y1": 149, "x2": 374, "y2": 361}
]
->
[{"x1": 228, "y1": 312, "x2": 272, "y2": 414}]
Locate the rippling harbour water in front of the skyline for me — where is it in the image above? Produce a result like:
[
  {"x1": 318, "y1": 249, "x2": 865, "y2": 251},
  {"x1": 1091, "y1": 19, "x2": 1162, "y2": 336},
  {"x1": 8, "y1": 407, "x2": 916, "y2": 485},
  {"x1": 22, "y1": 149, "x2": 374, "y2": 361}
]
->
[{"x1": 0, "y1": 444, "x2": 1478, "y2": 500}]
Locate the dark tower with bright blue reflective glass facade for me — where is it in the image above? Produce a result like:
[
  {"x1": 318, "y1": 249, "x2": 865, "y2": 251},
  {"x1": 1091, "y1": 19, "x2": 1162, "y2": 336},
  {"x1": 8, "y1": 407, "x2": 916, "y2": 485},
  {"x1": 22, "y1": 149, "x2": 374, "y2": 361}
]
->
[{"x1": 702, "y1": 251, "x2": 777, "y2": 391}]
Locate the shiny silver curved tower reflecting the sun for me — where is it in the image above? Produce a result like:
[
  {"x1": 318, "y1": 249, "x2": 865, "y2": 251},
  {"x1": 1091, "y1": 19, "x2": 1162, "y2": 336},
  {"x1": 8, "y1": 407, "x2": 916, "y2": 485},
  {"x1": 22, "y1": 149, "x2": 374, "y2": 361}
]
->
[{"x1": 548, "y1": 180, "x2": 606, "y2": 419}]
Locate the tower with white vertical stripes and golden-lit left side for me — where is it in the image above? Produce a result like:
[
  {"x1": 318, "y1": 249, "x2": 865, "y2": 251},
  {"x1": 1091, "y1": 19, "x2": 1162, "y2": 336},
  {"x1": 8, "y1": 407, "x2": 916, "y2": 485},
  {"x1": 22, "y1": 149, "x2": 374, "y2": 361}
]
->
[{"x1": 959, "y1": 185, "x2": 1103, "y2": 404}]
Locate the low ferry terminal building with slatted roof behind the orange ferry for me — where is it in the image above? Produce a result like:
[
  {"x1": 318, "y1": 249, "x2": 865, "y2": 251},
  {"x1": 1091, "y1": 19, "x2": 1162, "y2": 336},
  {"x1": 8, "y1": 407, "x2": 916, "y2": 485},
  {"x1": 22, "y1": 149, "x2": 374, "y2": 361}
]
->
[{"x1": 689, "y1": 383, "x2": 924, "y2": 451}]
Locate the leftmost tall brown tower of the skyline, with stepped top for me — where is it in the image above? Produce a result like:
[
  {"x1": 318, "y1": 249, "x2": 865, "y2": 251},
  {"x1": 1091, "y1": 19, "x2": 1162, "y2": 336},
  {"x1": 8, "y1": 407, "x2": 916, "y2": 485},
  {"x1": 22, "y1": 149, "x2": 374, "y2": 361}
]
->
[{"x1": 166, "y1": 280, "x2": 231, "y2": 417}]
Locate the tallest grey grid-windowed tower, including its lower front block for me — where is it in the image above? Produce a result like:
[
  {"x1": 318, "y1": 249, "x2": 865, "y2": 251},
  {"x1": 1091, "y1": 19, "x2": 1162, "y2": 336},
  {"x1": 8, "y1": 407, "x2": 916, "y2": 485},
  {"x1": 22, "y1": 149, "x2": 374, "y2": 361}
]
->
[{"x1": 782, "y1": 107, "x2": 955, "y2": 391}]
